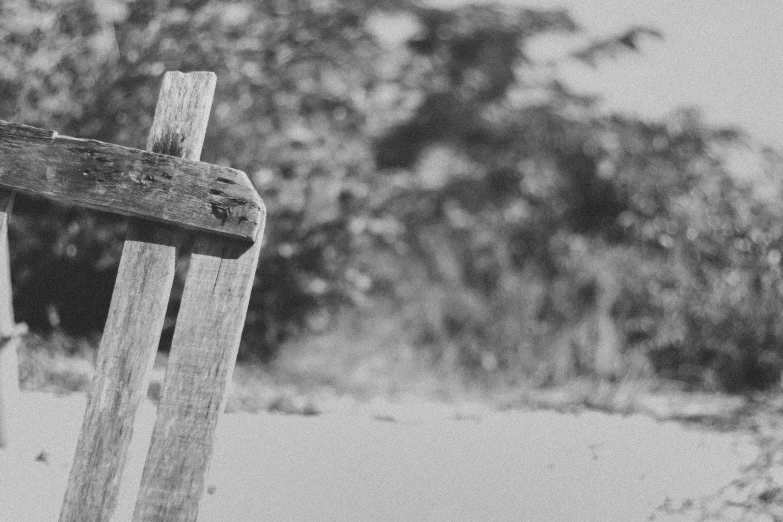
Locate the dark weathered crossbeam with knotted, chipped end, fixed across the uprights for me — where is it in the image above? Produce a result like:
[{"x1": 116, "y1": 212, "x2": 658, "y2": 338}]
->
[{"x1": 0, "y1": 121, "x2": 266, "y2": 241}]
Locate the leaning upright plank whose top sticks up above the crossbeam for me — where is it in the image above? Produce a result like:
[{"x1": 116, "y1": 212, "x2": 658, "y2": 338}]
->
[{"x1": 60, "y1": 73, "x2": 215, "y2": 522}]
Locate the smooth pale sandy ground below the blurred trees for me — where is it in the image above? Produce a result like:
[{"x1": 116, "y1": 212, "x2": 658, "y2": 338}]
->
[{"x1": 0, "y1": 393, "x2": 757, "y2": 522}]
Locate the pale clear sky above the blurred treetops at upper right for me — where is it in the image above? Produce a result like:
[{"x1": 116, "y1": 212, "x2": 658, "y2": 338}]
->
[{"x1": 428, "y1": 0, "x2": 783, "y2": 150}]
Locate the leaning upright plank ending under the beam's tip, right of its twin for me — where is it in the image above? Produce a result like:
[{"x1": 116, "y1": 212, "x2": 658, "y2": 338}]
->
[{"x1": 134, "y1": 215, "x2": 261, "y2": 522}]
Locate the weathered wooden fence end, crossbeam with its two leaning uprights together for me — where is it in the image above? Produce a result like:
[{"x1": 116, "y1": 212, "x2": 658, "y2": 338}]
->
[{"x1": 0, "y1": 72, "x2": 265, "y2": 522}]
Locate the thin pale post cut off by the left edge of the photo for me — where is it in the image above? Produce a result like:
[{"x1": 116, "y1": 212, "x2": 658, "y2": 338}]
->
[{"x1": 0, "y1": 190, "x2": 19, "y2": 447}]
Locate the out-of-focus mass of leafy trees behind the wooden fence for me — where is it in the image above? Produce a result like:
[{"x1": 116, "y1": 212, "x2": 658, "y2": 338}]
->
[{"x1": 0, "y1": 0, "x2": 783, "y2": 389}]
